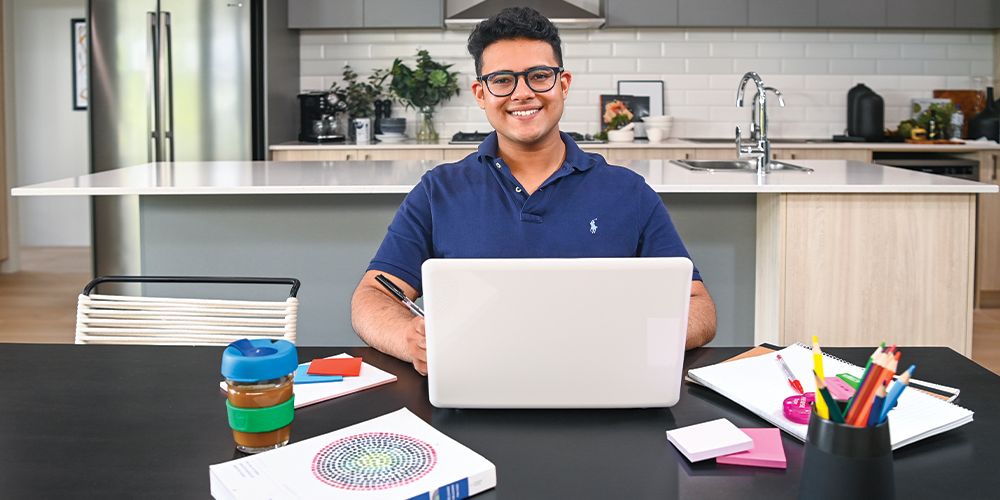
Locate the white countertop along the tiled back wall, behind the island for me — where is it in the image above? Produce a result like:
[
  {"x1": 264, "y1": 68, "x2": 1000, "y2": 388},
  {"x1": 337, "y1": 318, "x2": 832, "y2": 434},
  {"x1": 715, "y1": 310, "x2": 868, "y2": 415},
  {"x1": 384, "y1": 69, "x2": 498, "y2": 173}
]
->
[{"x1": 271, "y1": 139, "x2": 1000, "y2": 153}]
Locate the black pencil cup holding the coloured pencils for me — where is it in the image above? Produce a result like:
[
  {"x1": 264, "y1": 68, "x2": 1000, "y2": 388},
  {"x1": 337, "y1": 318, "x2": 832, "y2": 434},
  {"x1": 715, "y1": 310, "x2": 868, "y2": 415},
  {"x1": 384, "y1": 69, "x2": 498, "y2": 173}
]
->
[{"x1": 799, "y1": 410, "x2": 896, "y2": 500}]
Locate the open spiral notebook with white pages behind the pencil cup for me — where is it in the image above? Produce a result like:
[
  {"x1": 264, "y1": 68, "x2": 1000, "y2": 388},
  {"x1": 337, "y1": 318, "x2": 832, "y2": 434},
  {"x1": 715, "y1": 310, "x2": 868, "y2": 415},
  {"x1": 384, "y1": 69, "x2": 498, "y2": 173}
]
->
[{"x1": 688, "y1": 344, "x2": 973, "y2": 450}]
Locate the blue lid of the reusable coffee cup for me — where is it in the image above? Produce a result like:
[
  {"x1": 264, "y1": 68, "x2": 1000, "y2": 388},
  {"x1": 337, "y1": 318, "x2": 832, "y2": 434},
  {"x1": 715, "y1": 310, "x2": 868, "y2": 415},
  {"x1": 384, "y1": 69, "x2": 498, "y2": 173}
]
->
[{"x1": 222, "y1": 339, "x2": 299, "y2": 382}]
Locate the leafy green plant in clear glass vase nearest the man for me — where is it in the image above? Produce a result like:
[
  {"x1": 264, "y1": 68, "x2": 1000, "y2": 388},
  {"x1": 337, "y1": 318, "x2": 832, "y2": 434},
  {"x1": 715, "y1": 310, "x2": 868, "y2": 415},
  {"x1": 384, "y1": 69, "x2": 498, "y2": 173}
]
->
[{"x1": 389, "y1": 49, "x2": 458, "y2": 142}]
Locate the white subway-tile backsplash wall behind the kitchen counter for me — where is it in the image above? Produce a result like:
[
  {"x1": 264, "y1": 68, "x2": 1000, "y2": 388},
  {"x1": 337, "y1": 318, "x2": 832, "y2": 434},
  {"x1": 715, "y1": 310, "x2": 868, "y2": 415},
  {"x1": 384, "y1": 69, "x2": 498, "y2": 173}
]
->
[{"x1": 300, "y1": 29, "x2": 993, "y2": 138}]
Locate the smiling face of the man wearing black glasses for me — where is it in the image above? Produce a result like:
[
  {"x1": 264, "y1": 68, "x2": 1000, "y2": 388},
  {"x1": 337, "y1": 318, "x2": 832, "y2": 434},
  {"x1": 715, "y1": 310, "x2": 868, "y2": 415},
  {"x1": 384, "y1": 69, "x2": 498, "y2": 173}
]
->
[{"x1": 472, "y1": 38, "x2": 572, "y2": 145}]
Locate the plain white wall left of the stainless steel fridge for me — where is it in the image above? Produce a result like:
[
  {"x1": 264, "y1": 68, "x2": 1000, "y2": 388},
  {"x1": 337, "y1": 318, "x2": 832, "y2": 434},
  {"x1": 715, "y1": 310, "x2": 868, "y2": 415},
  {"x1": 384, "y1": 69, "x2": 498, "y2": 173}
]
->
[{"x1": 7, "y1": 0, "x2": 90, "y2": 246}]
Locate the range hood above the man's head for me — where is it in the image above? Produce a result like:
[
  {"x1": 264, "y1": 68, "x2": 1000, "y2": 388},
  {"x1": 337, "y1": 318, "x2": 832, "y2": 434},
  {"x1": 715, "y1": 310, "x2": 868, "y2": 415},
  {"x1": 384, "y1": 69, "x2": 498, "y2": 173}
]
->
[{"x1": 444, "y1": 0, "x2": 604, "y2": 29}]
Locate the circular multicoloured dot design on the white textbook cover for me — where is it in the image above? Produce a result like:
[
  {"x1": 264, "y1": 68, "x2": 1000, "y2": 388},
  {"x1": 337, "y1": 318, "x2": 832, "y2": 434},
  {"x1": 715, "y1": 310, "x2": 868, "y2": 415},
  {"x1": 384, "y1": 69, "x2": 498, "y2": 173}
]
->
[{"x1": 312, "y1": 432, "x2": 437, "y2": 491}]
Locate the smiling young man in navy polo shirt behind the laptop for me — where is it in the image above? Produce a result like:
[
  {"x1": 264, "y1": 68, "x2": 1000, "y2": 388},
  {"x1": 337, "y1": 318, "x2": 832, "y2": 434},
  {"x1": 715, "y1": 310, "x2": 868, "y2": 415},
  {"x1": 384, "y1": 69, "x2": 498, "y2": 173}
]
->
[{"x1": 351, "y1": 7, "x2": 715, "y2": 374}]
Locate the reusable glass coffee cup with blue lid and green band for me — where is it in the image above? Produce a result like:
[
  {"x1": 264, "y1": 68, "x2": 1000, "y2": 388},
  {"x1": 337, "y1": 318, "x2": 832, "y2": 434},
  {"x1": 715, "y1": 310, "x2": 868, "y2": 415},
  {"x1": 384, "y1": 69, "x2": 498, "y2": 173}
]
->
[{"x1": 222, "y1": 339, "x2": 299, "y2": 453}]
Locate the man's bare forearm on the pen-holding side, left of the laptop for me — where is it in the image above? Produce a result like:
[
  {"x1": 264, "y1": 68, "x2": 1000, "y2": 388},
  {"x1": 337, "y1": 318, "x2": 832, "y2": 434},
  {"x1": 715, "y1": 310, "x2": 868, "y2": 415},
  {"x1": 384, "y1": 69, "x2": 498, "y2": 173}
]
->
[{"x1": 351, "y1": 287, "x2": 413, "y2": 362}]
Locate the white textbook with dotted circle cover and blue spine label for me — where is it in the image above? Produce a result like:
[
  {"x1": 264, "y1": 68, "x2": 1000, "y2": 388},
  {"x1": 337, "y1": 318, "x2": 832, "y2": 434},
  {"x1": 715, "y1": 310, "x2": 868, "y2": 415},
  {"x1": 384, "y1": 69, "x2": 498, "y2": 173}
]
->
[{"x1": 208, "y1": 408, "x2": 497, "y2": 500}]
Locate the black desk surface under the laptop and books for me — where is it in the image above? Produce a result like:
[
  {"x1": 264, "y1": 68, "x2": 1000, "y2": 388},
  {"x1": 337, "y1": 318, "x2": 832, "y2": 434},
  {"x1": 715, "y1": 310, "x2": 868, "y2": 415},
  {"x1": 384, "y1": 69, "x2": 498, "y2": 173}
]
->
[{"x1": 0, "y1": 344, "x2": 1000, "y2": 499}]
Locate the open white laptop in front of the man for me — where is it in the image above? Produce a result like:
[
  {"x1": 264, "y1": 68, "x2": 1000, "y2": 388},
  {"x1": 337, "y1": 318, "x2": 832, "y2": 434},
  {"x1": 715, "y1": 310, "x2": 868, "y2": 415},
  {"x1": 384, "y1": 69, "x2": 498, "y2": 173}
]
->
[{"x1": 423, "y1": 257, "x2": 692, "y2": 408}]
